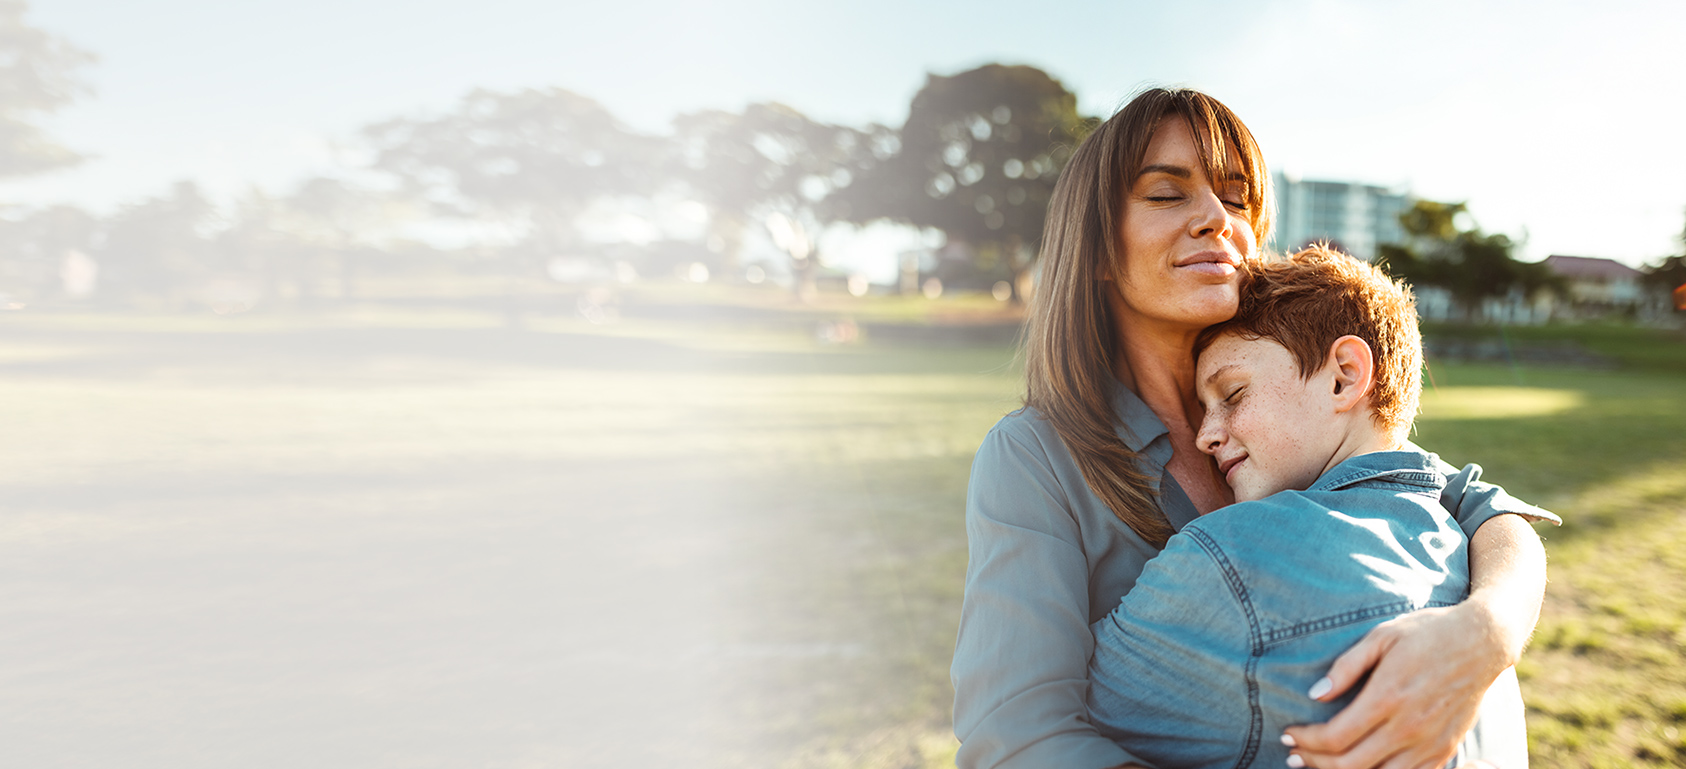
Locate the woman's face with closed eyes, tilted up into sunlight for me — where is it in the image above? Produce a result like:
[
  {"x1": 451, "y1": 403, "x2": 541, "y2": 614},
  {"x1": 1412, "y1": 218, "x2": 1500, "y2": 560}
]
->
[{"x1": 1113, "y1": 116, "x2": 1254, "y2": 331}]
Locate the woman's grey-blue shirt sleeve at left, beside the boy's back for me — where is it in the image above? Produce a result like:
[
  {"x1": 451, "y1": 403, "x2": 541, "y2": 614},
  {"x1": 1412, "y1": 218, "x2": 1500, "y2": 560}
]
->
[{"x1": 951, "y1": 425, "x2": 1140, "y2": 769}]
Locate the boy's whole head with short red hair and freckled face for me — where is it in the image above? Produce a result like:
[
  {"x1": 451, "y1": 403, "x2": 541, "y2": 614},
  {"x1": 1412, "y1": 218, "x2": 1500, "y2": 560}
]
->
[{"x1": 1194, "y1": 246, "x2": 1423, "y2": 501}]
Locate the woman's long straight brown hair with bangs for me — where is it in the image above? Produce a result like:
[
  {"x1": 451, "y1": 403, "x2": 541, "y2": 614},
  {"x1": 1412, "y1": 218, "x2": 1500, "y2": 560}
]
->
[{"x1": 1025, "y1": 88, "x2": 1271, "y2": 546}]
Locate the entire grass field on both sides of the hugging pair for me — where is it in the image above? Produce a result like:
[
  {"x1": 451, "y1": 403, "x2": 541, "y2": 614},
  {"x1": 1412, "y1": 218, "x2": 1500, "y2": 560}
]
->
[{"x1": 0, "y1": 304, "x2": 1686, "y2": 767}]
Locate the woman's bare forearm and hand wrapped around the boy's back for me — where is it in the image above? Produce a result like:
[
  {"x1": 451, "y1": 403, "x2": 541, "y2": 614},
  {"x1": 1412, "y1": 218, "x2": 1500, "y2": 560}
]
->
[{"x1": 1283, "y1": 514, "x2": 1546, "y2": 769}]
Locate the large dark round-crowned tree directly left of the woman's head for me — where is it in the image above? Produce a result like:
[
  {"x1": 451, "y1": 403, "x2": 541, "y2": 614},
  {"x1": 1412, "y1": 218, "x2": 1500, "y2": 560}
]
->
[{"x1": 838, "y1": 64, "x2": 1098, "y2": 302}]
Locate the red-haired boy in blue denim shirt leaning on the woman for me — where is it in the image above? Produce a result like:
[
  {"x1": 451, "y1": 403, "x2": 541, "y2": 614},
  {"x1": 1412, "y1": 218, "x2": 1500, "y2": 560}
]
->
[{"x1": 1087, "y1": 248, "x2": 1553, "y2": 769}]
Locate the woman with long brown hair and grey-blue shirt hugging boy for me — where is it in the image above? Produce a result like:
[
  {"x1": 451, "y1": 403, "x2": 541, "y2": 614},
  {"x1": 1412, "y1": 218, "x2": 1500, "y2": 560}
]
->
[{"x1": 953, "y1": 89, "x2": 1544, "y2": 769}]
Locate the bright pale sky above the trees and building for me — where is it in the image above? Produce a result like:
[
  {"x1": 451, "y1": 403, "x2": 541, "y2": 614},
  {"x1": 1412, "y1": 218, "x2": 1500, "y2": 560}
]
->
[{"x1": 0, "y1": 0, "x2": 1686, "y2": 265}]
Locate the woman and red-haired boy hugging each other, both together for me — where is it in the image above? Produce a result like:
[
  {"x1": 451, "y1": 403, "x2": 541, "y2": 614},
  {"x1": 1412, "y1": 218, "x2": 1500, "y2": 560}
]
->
[{"x1": 953, "y1": 89, "x2": 1556, "y2": 769}]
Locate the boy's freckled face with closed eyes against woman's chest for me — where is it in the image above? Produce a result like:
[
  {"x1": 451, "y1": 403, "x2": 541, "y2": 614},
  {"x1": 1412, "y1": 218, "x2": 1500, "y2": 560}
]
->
[{"x1": 1195, "y1": 334, "x2": 1340, "y2": 503}]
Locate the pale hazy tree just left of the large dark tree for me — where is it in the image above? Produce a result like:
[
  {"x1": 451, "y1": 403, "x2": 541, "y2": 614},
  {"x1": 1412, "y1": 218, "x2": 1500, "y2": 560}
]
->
[{"x1": 673, "y1": 103, "x2": 889, "y2": 298}]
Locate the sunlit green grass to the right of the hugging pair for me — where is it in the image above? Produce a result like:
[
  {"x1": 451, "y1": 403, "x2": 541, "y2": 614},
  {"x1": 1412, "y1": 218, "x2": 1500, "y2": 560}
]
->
[{"x1": 1396, "y1": 325, "x2": 1686, "y2": 767}]
